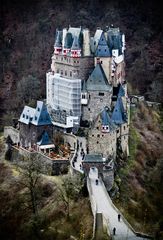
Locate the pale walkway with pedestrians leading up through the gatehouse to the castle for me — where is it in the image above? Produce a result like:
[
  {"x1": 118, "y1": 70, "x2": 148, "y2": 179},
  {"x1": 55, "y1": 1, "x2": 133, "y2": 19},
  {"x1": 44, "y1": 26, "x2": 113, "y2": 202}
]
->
[{"x1": 74, "y1": 137, "x2": 148, "y2": 240}]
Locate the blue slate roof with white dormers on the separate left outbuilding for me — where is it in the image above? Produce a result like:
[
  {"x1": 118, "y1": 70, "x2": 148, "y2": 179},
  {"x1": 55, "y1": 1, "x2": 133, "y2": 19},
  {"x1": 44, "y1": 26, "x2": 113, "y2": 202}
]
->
[{"x1": 19, "y1": 101, "x2": 52, "y2": 126}]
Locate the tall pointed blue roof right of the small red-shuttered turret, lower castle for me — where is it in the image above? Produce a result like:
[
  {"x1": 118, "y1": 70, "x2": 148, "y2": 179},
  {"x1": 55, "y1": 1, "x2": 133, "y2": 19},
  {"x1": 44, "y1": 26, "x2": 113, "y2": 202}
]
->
[{"x1": 111, "y1": 97, "x2": 126, "y2": 124}]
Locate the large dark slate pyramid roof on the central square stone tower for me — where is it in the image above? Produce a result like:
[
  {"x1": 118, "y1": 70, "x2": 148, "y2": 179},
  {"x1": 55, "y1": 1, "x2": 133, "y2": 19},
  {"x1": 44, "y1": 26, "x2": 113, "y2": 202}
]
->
[{"x1": 86, "y1": 63, "x2": 112, "y2": 91}]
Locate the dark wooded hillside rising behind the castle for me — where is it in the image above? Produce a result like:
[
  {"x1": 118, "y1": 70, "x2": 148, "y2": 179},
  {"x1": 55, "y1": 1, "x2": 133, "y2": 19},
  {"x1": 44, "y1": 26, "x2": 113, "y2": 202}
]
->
[{"x1": 0, "y1": 0, "x2": 163, "y2": 125}]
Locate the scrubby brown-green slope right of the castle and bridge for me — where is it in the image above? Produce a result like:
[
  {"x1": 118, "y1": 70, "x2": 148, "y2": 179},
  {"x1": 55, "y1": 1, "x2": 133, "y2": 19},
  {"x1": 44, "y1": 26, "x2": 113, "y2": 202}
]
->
[{"x1": 115, "y1": 104, "x2": 163, "y2": 239}]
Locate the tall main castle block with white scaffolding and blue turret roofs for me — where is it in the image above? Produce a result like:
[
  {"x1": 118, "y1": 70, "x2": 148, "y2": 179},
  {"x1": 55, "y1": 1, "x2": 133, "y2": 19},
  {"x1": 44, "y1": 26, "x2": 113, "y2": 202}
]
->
[{"x1": 46, "y1": 26, "x2": 129, "y2": 158}]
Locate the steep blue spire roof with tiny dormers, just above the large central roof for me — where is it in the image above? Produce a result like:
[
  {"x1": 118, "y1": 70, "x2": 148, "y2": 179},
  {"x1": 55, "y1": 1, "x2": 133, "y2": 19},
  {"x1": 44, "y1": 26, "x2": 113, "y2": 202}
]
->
[{"x1": 95, "y1": 32, "x2": 111, "y2": 57}]
